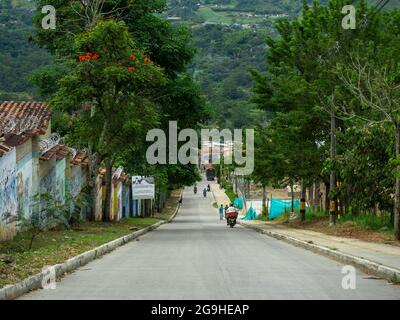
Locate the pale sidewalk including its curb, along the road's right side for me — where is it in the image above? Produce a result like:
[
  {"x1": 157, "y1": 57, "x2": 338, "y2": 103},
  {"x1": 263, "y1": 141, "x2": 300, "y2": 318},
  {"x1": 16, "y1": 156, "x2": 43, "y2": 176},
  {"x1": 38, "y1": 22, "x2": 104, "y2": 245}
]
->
[{"x1": 211, "y1": 183, "x2": 400, "y2": 282}]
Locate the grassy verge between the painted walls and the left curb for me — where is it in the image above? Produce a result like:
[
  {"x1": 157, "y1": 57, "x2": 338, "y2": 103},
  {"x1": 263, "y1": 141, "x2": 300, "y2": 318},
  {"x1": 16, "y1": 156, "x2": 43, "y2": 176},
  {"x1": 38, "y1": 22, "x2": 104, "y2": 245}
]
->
[{"x1": 0, "y1": 191, "x2": 180, "y2": 288}]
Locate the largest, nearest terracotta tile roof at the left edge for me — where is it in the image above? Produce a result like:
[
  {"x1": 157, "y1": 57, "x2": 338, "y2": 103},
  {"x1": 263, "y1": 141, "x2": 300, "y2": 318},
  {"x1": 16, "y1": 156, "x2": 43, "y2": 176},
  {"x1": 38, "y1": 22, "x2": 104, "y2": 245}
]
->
[{"x1": 0, "y1": 101, "x2": 51, "y2": 156}]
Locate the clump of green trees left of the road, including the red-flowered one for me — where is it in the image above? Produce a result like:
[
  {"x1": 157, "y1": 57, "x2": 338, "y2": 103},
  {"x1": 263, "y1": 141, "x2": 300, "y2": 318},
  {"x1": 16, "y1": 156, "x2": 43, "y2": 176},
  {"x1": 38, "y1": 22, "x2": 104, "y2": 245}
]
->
[{"x1": 27, "y1": 0, "x2": 209, "y2": 219}]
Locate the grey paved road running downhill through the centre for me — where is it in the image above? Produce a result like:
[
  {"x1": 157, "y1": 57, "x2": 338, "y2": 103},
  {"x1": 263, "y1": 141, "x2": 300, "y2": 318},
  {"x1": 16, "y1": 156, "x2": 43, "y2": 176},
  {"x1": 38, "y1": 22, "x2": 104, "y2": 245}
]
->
[{"x1": 22, "y1": 185, "x2": 400, "y2": 300}]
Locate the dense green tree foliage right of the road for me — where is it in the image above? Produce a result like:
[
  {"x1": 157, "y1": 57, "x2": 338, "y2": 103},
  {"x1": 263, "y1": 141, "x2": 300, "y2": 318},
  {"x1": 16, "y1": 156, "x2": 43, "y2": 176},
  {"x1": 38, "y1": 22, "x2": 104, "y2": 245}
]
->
[{"x1": 253, "y1": 0, "x2": 400, "y2": 236}]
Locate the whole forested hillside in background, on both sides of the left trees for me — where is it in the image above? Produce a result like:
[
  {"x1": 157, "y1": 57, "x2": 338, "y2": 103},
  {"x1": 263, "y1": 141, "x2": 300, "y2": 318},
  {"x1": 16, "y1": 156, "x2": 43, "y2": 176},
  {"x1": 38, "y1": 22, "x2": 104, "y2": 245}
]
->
[{"x1": 0, "y1": 0, "x2": 400, "y2": 111}]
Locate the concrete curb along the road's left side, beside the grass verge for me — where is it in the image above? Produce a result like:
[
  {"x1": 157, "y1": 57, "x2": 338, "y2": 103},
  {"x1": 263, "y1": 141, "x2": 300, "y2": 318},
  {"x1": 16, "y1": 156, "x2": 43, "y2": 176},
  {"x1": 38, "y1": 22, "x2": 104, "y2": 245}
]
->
[{"x1": 0, "y1": 191, "x2": 183, "y2": 300}]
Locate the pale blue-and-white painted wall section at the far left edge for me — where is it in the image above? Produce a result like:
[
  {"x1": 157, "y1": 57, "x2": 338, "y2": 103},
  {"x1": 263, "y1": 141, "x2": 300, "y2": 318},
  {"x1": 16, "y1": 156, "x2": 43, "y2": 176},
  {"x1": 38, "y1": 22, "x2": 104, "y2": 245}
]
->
[{"x1": 0, "y1": 148, "x2": 18, "y2": 240}]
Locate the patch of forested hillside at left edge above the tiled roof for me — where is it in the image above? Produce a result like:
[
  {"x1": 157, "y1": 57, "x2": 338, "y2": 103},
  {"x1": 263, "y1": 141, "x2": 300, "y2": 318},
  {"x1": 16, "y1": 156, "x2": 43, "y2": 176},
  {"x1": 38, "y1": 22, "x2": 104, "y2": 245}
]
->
[{"x1": 0, "y1": 0, "x2": 51, "y2": 100}]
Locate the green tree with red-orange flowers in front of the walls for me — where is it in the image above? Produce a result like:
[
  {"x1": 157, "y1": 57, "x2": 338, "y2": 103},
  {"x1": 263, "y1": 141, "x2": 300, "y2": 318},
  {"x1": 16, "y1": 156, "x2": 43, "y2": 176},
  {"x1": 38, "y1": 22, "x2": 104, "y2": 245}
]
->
[{"x1": 51, "y1": 20, "x2": 165, "y2": 220}]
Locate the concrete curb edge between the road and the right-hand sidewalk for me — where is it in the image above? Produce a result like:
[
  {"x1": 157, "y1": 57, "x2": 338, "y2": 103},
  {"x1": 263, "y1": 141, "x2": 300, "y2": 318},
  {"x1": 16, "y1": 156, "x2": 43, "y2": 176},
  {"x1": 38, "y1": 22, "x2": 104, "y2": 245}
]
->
[{"x1": 238, "y1": 222, "x2": 400, "y2": 284}]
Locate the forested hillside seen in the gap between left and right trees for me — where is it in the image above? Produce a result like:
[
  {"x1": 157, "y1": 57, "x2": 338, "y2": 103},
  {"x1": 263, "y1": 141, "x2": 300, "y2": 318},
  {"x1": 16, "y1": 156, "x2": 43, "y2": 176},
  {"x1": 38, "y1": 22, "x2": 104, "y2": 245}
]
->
[{"x1": 166, "y1": 0, "x2": 400, "y2": 128}]
